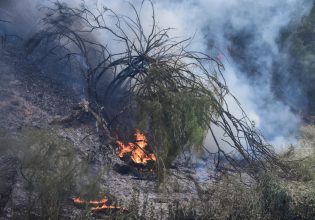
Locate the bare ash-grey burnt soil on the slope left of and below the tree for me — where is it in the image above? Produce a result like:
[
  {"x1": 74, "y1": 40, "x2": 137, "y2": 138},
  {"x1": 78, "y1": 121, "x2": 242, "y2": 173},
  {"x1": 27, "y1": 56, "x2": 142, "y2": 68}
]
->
[{"x1": 0, "y1": 44, "x2": 215, "y2": 219}]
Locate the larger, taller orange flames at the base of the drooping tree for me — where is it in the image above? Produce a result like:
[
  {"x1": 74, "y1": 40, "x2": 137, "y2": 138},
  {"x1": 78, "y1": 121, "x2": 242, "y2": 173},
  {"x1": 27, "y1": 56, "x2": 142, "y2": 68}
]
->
[{"x1": 116, "y1": 130, "x2": 156, "y2": 165}]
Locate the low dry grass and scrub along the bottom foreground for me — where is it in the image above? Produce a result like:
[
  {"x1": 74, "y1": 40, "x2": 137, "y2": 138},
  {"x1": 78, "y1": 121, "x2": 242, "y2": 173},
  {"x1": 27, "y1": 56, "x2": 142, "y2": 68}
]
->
[{"x1": 0, "y1": 126, "x2": 315, "y2": 220}]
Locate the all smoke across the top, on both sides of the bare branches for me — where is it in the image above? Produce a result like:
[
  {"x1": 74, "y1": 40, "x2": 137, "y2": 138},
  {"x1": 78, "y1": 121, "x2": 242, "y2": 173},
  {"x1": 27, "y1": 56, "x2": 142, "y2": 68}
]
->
[{"x1": 0, "y1": 0, "x2": 313, "y2": 150}]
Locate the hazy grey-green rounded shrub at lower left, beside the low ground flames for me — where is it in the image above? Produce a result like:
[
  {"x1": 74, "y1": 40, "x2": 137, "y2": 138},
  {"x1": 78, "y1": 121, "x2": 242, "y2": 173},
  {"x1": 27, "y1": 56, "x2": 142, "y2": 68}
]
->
[{"x1": 17, "y1": 128, "x2": 80, "y2": 219}]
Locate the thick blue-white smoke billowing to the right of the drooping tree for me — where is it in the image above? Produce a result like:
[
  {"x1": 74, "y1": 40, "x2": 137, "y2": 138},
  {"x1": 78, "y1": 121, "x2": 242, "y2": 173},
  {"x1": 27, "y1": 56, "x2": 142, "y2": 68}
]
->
[{"x1": 148, "y1": 0, "x2": 313, "y2": 150}]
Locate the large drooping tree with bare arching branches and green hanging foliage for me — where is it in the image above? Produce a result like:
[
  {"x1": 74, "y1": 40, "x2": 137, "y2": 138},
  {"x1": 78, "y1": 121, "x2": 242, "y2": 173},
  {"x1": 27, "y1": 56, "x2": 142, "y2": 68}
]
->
[{"x1": 26, "y1": 1, "x2": 285, "y2": 175}]
